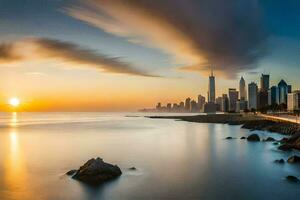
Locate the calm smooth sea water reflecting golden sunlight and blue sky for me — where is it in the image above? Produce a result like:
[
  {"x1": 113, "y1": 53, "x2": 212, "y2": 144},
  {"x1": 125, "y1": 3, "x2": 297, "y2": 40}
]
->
[{"x1": 0, "y1": 113, "x2": 300, "y2": 200}]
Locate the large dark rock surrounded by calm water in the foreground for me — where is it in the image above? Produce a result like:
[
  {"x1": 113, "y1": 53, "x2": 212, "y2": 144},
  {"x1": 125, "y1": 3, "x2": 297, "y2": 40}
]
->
[{"x1": 72, "y1": 158, "x2": 122, "y2": 185}]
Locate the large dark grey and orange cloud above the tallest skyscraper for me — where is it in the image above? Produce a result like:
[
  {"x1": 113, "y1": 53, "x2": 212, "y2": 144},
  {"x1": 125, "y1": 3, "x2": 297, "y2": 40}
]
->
[{"x1": 66, "y1": 0, "x2": 267, "y2": 77}]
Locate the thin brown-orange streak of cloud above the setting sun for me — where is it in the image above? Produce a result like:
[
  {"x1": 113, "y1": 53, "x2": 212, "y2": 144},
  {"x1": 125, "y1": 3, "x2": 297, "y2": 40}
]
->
[{"x1": 0, "y1": 38, "x2": 155, "y2": 77}]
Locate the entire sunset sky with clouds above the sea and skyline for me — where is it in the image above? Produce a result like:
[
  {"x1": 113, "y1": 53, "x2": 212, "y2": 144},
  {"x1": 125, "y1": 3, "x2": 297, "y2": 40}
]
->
[{"x1": 0, "y1": 0, "x2": 300, "y2": 111}]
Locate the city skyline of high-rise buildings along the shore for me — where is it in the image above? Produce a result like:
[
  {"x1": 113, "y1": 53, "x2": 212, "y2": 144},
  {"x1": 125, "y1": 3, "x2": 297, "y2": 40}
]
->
[{"x1": 146, "y1": 72, "x2": 300, "y2": 113}]
